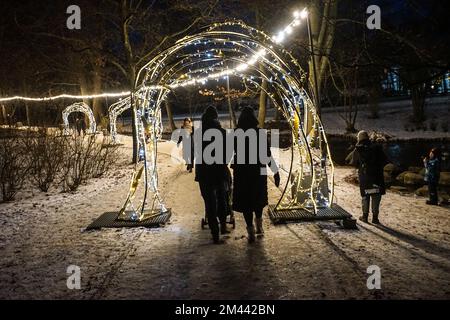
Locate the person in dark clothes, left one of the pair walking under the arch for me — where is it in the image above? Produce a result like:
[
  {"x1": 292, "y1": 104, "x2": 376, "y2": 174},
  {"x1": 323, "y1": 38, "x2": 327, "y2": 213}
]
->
[{"x1": 194, "y1": 106, "x2": 229, "y2": 244}]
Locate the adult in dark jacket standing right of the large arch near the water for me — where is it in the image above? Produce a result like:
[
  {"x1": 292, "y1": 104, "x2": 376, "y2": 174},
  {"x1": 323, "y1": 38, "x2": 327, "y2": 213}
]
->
[{"x1": 347, "y1": 131, "x2": 387, "y2": 224}]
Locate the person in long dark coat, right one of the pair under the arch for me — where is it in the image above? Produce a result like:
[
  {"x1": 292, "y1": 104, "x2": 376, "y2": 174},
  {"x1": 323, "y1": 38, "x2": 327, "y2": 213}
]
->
[{"x1": 232, "y1": 107, "x2": 280, "y2": 243}]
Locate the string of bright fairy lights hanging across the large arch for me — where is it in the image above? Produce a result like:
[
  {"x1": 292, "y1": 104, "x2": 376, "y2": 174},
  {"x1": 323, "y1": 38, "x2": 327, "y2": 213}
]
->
[{"x1": 0, "y1": 8, "x2": 308, "y2": 102}]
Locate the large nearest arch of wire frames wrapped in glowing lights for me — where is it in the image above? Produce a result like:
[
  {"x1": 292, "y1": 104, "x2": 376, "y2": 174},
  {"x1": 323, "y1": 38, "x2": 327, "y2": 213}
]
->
[{"x1": 119, "y1": 21, "x2": 334, "y2": 220}]
